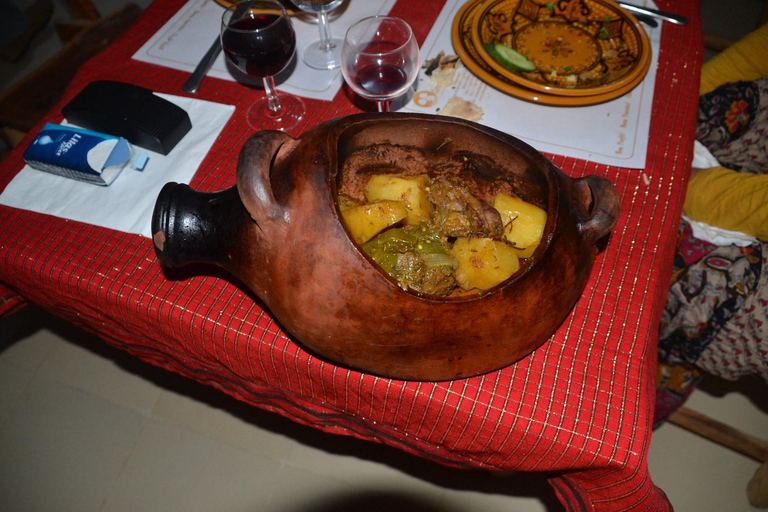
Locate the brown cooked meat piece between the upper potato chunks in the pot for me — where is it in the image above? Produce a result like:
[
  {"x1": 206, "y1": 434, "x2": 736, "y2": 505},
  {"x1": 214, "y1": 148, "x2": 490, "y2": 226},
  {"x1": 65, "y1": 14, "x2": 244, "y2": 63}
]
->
[{"x1": 427, "y1": 178, "x2": 504, "y2": 240}]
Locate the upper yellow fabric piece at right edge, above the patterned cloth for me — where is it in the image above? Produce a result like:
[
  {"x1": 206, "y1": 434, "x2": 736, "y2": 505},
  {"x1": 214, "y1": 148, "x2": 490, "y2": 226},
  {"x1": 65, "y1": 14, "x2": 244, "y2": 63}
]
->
[{"x1": 699, "y1": 24, "x2": 768, "y2": 95}]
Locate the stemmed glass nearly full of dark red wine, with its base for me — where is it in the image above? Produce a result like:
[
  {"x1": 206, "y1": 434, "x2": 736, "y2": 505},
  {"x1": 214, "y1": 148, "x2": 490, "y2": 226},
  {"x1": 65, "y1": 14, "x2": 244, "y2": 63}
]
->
[{"x1": 221, "y1": 0, "x2": 306, "y2": 130}]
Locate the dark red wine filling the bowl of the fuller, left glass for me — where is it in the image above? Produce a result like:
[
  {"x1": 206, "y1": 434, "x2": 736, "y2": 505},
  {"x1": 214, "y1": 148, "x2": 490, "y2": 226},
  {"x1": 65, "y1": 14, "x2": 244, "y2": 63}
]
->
[{"x1": 221, "y1": 14, "x2": 296, "y2": 78}]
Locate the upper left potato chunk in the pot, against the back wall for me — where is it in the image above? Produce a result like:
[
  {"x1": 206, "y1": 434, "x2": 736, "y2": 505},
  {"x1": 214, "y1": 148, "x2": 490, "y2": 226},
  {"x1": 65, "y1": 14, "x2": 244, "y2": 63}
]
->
[{"x1": 365, "y1": 174, "x2": 434, "y2": 226}]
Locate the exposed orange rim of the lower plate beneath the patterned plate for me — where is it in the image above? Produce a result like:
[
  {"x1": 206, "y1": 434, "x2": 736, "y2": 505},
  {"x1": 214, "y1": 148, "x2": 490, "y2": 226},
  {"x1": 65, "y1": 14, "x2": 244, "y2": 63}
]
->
[{"x1": 451, "y1": 0, "x2": 642, "y2": 106}]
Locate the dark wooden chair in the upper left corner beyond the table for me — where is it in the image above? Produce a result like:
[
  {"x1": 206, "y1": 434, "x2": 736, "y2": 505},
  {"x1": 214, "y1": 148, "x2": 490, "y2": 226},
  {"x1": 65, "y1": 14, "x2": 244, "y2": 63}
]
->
[{"x1": 0, "y1": 0, "x2": 142, "y2": 158}]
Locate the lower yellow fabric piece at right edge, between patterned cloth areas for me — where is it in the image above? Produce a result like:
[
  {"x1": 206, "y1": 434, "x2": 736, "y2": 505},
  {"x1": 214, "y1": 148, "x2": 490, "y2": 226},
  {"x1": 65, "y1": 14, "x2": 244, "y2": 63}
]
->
[{"x1": 683, "y1": 167, "x2": 768, "y2": 242}]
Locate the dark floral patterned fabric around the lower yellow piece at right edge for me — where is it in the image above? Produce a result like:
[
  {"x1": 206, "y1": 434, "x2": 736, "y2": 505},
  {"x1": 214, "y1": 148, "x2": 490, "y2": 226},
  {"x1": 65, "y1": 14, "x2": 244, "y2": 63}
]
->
[{"x1": 655, "y1": 78, "x2": 768, "y2": 423}]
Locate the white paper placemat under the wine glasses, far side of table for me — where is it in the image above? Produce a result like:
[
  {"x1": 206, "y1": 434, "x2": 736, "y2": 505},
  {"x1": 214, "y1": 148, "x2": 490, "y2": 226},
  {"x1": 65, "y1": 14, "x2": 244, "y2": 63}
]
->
[{"x1": 133, "y1": 0, "x2": 396, "y2": 101}]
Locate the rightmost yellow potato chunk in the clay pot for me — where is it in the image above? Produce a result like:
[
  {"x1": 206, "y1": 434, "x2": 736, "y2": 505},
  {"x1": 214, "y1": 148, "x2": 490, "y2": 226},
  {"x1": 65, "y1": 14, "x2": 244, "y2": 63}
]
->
[{"x1": 493, "y1": 194, "x2": 547, "y2": 258}]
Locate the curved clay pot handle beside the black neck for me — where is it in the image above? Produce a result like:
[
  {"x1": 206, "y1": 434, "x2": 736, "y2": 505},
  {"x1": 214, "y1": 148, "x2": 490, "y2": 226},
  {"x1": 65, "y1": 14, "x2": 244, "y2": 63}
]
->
[{"x1": 237, "y1": 130, "x2": 295, "y2": 222}]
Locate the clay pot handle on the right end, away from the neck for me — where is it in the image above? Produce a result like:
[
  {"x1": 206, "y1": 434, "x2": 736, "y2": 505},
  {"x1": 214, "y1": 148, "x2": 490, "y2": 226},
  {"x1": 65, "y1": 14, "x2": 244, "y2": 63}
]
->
[{"x1": 575, "y1": 175, "x2": 621, "y2": 245}]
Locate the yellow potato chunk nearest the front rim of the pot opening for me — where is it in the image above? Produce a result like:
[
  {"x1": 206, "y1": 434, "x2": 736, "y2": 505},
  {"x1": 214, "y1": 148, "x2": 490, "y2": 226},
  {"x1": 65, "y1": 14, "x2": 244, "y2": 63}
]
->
[{"x1": 451, "y1": 237, "x2": 520, "y2": 290}]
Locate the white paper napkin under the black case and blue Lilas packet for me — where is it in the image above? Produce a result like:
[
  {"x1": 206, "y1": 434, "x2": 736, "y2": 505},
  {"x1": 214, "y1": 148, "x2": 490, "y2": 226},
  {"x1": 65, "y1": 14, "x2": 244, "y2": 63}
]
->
[{"x1": 0, "y1": 94, "x2": 235, "y2": 238}]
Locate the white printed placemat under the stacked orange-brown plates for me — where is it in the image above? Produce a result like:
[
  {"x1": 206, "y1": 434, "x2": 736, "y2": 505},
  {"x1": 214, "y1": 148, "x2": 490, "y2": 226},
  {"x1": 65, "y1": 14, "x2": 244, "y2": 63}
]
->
[{"x1": 402, "y1": 0, "x2": 661, "y2": 169}]
